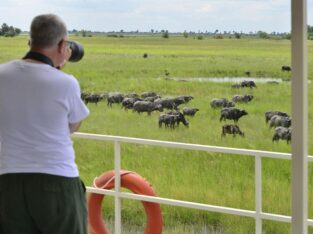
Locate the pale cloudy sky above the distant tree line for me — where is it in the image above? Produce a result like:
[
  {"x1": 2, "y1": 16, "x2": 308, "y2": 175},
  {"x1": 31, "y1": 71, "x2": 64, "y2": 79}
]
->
[{"x1": 0, "y1": 0, "x2": 313, "y2": 32}]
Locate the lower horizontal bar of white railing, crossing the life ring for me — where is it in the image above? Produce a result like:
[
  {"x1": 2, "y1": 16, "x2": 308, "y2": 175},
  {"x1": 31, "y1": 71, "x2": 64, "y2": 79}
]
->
[{"x1": 87, "y1": 187, "x2": 313, "y2": 226}]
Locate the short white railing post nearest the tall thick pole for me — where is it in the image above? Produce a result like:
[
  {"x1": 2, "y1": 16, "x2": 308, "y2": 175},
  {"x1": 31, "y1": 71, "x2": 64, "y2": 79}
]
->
[{"x1": 255, "y1": 155, "x2": 262, "y2": 234}]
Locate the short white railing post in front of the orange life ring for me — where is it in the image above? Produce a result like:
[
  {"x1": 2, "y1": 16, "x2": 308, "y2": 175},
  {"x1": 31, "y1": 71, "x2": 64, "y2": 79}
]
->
[{"x1": 114, "y1": 141, "x2": 122, "y2": 234}]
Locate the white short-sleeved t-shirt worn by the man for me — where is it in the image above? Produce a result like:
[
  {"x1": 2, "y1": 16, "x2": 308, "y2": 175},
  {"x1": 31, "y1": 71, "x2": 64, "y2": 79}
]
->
[{"x1": 0, "y1": 60, "x2": 89, "y2": 177}]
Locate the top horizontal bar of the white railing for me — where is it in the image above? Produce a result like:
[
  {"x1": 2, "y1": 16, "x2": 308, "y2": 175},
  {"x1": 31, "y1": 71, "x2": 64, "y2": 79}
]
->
[{"x1": 73, "y1": 132, "x2": 313, "y2": 162}]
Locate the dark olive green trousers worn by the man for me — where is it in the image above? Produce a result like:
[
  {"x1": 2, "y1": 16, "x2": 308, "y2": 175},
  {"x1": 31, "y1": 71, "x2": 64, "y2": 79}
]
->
[{"x1": 0, "y1": 173, "x2": 87, "y2": 234}]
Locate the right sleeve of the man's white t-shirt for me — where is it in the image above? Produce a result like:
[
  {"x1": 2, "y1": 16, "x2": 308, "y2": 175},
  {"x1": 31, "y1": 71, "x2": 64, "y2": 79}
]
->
[{"x1": 68, "y1": 78, "x2": 89, "y2": 123}]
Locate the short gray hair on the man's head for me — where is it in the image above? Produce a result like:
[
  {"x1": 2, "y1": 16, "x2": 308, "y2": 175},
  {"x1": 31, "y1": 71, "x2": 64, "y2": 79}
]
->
[{"x1": 30, "y1": 14, "x2": 67, "y2": 48}]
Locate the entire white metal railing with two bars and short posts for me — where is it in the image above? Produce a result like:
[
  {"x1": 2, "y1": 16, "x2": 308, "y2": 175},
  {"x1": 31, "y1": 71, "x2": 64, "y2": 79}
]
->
[{"x1": 73, "y1": 133, "x2": 313, "y2": 234}]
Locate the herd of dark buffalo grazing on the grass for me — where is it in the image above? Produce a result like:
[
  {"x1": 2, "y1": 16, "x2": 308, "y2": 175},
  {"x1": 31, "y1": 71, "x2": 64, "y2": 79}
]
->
[{"x1": 81, "y1": 80, "x2": 291, "y2": 144}]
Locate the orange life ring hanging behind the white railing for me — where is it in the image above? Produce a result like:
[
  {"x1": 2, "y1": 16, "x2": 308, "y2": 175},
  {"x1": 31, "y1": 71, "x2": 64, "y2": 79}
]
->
[{"x1": 88, "y1": 171, "x2": 163, "y2": 234}]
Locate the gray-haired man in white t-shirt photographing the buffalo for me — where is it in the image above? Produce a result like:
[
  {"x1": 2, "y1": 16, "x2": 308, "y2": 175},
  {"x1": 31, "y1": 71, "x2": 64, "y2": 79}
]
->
[{"x1": 0, "y1": 14, "x2": 89, "y2": 234}]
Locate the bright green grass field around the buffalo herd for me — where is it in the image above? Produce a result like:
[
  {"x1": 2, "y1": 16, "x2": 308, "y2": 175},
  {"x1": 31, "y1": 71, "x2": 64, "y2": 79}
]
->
[{"x1": 0, "y1": 36, "x2": 313, "y2": 234}]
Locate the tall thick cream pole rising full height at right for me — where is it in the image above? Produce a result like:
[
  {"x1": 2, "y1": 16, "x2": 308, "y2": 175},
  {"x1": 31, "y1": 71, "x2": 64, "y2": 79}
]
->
[{"x1": 291, "y1": 0, "x2": 308, "y2": 234}]
